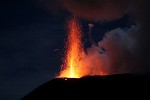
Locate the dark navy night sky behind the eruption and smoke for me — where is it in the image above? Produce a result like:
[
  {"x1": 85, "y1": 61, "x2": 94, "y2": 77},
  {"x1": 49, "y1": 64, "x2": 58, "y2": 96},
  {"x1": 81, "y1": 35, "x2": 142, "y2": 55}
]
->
[{"x1": 0, "y1": 0, "x2": 148, "y2": 100}]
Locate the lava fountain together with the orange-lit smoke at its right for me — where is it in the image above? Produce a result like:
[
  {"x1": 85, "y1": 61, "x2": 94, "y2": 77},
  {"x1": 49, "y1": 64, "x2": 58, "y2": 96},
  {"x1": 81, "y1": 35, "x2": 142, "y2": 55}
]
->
[{"x1": 58, "y1": 17, "x2": 107, "y2": 78}]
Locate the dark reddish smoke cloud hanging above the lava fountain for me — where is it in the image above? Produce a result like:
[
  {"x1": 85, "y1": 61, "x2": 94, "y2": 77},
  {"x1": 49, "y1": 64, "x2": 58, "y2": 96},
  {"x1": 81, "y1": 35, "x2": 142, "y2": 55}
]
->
[{"x1": 61, "y1": 0, "x2": 129, "y2": 20}]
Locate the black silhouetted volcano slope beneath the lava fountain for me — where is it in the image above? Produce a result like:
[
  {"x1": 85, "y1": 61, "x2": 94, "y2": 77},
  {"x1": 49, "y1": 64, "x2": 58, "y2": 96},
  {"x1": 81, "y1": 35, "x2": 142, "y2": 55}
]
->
[{"x1": 21, "y1": 74, "x2": 150, "y2": 100}]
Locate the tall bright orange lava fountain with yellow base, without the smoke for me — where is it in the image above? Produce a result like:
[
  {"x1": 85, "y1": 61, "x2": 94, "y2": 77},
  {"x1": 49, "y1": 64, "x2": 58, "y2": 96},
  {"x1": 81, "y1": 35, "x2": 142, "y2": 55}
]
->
[{"x1": 59, "y1": 17, "x2": 84, "y2": 78}]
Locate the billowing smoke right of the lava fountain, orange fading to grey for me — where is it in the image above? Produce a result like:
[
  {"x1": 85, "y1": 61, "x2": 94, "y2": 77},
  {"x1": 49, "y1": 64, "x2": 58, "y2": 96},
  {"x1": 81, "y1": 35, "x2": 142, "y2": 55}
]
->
[{"x1": 76, "y1": 26, "x2": 139, "y2": 75}]
